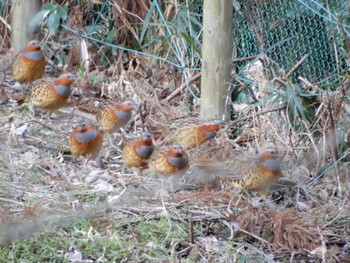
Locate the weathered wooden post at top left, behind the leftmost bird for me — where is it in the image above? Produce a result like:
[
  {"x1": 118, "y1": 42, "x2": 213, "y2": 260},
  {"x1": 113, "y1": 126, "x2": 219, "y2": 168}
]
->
[{"x1": 11, "y1": 0, "x2": 41, "y2": 54}]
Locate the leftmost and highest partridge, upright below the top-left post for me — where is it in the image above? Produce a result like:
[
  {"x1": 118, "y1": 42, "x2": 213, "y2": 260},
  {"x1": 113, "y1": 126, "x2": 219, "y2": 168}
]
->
[{"x1": 12, "y1": 40, "x2": 46, "y2": 83}]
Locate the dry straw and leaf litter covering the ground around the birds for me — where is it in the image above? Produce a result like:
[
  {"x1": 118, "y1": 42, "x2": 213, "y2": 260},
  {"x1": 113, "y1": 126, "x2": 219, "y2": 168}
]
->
[{"x1": 0, "y1": 49, "x2": 350, "y2": 262}]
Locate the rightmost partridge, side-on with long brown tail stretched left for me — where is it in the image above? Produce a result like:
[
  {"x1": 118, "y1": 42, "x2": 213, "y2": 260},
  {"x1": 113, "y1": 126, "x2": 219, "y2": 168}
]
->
[{"x1": 193, "y1": 147, "x2": 282, "y2": 197}]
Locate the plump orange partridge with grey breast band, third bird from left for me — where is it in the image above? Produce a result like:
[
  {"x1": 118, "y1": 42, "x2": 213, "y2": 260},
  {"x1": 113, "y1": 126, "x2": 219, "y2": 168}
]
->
[{"x1": 69, "y1": 123, "x2": 103, "y2": 158}]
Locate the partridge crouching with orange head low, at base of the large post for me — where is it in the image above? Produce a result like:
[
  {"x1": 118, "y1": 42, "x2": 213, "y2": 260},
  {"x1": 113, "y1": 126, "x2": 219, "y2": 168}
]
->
[{"x1": 163, "y1": 117, "x2": 224, "y2": 150}]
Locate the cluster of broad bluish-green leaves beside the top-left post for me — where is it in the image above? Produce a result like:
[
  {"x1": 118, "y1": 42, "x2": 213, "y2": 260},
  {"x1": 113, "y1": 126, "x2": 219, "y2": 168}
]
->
[{"x1": 28, "y1": 3, "x2": 68, "y2": 36}]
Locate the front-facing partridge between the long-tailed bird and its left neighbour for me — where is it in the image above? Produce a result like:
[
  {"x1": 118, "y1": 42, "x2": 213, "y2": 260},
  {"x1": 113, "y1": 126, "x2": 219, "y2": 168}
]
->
[{"x1": 148, "y1": 144, "x2": 189, "y2": 176}]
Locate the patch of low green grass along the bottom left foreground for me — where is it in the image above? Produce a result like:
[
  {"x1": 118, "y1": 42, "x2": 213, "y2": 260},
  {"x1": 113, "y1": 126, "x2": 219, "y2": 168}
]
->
[{"x1": 0, "y1": 217, "x2": 188, "y2": 262}]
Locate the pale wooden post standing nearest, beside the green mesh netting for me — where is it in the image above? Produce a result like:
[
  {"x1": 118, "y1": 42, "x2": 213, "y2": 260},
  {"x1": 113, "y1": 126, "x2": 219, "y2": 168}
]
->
[{"x1": 201, "y1": 0, "x2": 233, "y2": 119}]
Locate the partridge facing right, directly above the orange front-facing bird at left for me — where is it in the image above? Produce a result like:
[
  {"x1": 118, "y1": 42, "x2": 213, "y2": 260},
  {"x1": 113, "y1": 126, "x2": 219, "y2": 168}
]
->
[{"x1": 96, "y1": 100, "x2": 136, "y2": 133}]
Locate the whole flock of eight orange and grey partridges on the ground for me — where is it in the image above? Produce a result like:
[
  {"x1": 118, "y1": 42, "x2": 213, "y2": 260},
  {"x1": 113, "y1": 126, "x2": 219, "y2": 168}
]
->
[{"x1": 12, "y1": 40, "x2": 288, "y2": 198}]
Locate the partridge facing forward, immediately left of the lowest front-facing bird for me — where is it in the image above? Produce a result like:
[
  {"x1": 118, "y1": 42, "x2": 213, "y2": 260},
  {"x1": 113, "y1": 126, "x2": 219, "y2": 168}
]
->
[{"x1": 122, "y1": 131, "x2": 154, "y2": 171}]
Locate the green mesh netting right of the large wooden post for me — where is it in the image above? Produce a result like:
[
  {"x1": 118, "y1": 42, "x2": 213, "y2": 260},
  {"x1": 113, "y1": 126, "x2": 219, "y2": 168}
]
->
[{"x1": 233, "y1": 0, "x2": 350, "y2": 84}]
